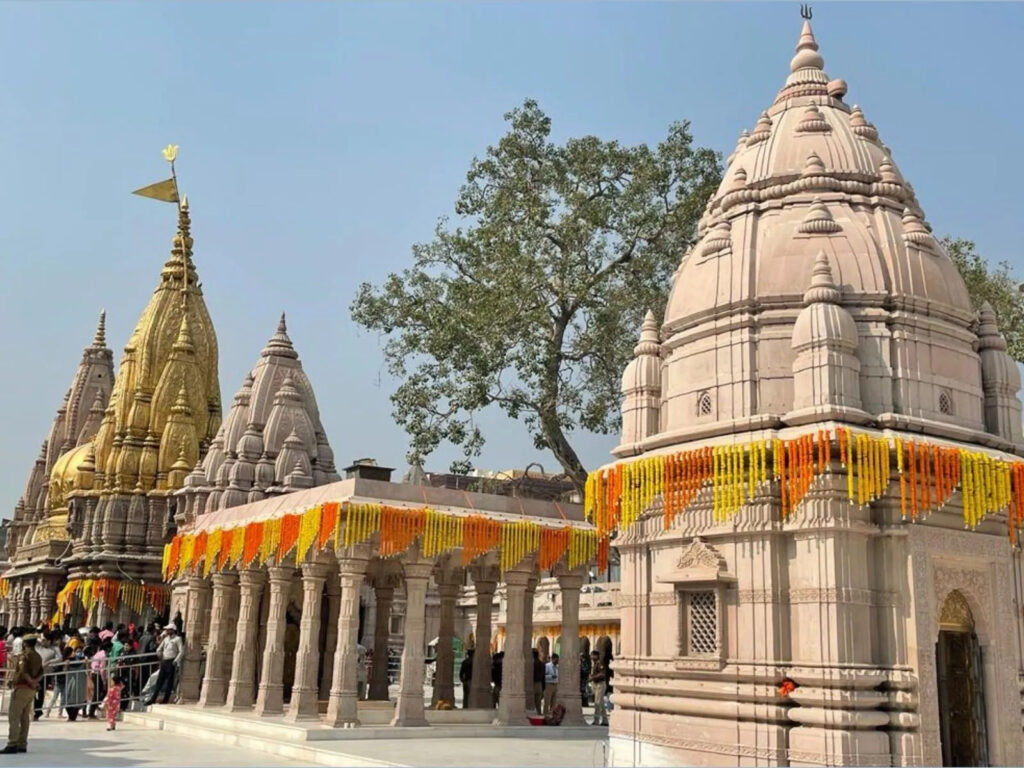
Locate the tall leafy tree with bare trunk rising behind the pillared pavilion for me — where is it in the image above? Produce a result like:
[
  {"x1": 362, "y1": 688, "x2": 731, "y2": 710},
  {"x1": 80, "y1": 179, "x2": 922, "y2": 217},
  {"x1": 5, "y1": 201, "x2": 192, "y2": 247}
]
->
[{"x1": 351, "y1": 100, "x2": 721, "y2": 488}]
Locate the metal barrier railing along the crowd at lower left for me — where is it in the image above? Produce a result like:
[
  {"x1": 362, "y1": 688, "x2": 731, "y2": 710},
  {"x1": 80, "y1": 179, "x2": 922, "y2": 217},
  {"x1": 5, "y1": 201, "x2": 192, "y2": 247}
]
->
[{"x1": 3, "y1": 653, "x2": 164, "y2": 719}]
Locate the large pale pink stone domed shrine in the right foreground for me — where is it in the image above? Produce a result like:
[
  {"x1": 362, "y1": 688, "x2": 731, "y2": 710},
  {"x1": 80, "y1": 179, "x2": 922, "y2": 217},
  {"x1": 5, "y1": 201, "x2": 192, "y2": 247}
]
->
[{"x1": 587, "y1": 13, "x2": 1024, "y2": 766}]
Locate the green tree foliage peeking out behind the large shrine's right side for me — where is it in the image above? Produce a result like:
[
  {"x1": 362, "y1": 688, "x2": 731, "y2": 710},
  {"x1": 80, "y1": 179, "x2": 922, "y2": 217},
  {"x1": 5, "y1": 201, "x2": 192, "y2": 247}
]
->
[{"x1": 942, "y1": 234, "x2": 1024, "y2": 362}]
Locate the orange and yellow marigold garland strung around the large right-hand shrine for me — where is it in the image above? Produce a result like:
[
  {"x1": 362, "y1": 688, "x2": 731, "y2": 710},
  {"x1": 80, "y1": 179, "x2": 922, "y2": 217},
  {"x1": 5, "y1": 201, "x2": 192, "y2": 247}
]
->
[{"x1": 584, "y1": 427, "x2": 1024, "y2": 542}]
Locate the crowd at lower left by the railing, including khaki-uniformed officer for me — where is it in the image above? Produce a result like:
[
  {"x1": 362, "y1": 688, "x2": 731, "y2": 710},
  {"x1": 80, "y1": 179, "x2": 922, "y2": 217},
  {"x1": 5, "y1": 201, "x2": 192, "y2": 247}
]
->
[{"x1": 0, "y1": 614, "x2": 184, "y2": 755}]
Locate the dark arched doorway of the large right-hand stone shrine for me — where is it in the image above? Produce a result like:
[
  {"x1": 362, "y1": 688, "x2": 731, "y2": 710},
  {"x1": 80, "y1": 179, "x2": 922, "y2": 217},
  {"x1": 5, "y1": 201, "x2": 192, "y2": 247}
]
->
[{"x1": 935, "y1": 590, "x2": 988, "y2": 766}]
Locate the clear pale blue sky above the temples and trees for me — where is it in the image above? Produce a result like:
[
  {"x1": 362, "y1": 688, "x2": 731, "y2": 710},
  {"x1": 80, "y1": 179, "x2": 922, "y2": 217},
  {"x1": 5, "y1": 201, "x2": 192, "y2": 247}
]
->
[{"x1": 0, "y1": 2, "x2": 1024, "y2": 514}]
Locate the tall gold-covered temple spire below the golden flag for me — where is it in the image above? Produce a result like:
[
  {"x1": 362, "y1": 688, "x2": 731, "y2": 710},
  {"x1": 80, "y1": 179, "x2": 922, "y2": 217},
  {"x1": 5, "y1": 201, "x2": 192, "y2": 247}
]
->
[{"x1": 89, "y1": 199, "x2": 220, "y2": 492}]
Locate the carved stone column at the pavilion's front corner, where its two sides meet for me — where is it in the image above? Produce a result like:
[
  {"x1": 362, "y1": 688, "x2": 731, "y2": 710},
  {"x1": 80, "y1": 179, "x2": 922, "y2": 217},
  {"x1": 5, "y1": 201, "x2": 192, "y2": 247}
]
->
[{"x1": 325, "y1": 557, "x2": 367, "y2": 728}]
